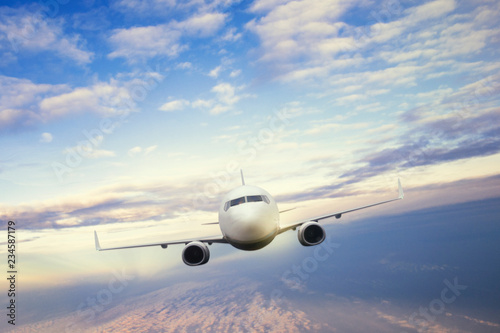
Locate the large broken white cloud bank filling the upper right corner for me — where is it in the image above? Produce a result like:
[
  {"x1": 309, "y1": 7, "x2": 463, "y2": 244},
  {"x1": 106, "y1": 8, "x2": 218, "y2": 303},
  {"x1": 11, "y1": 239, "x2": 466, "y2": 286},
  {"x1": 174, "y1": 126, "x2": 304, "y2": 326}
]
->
[{"x1": 246, "y1": 0, "x2": 500, "y2": 84}]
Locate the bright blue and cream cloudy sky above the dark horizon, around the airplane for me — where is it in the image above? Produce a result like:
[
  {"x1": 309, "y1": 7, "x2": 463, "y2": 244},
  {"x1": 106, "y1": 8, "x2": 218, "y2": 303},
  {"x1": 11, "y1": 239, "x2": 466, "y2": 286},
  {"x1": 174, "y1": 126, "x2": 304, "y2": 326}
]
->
[{"x1": 0, "y1": 0, "x2": 500, "y2": 330}]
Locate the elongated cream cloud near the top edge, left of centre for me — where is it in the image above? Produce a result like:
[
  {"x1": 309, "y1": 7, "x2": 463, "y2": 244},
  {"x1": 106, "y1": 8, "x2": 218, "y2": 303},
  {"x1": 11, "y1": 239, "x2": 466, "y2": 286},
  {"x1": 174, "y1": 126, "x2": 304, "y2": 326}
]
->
[{"x1": 108, "y1": 13, "x2": 226, "y2": 62}]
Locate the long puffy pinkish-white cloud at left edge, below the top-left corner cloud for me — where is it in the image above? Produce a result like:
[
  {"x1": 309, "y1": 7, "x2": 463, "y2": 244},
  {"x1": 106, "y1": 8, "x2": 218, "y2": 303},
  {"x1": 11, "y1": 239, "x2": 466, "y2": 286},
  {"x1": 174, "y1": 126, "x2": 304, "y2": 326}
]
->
[{"x1": 0, "y1": 72, "x2": 163, "y2": 133}]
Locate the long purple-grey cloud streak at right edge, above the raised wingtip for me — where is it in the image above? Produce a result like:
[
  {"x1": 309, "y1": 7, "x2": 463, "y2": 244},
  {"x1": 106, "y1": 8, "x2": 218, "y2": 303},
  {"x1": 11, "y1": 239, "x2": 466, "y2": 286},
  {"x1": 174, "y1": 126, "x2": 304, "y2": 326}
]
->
[{"x1": 279, "y1": 68, "x2": 500, "y2": 200}]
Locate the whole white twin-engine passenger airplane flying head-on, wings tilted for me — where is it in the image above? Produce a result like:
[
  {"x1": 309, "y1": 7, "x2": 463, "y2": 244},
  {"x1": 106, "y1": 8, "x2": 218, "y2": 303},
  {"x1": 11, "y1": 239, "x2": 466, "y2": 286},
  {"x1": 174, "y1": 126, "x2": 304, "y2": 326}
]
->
[{"x1": 94, "y1": 171, "x2": 404, "y2": 266}]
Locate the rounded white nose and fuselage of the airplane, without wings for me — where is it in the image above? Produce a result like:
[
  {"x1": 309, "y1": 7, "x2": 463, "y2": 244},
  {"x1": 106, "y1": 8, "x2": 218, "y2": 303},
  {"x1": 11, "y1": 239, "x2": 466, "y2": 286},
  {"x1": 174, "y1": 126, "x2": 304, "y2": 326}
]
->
[{"x1": 219, "y1": 185, "x2": 279, "y2": 251}]
